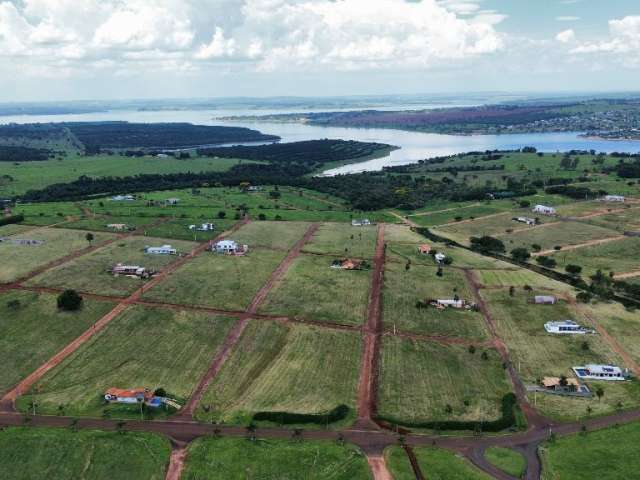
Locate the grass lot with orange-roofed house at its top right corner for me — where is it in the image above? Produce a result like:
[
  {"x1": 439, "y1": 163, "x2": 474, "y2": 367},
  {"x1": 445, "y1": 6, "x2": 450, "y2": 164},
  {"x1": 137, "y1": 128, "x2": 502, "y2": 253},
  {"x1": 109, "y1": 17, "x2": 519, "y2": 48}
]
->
[{"x1": 259, "y1": 254, "x2": 371, "y2": 325}]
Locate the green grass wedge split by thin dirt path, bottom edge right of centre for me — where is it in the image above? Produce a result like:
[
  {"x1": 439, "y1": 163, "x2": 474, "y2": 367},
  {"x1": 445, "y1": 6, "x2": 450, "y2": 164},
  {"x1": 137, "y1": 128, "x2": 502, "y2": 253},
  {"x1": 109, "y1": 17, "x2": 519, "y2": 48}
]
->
[{"x1": 384, "y1": 447, "x2": 491, "y2": 480}]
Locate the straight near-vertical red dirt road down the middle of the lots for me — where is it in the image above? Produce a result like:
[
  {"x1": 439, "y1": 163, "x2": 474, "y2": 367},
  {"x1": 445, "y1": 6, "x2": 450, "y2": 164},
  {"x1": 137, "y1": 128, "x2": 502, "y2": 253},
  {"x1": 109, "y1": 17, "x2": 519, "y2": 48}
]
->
[{"x1": 357, "y1": 224, "x2": 386, "y2": 428}]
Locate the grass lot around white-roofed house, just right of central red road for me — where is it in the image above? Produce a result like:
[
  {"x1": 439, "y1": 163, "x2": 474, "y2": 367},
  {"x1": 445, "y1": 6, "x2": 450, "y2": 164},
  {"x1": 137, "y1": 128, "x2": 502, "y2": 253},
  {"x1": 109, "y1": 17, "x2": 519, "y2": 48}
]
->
[{"x1": 382, "y1": 257, "x2": 488, "y2": 341}]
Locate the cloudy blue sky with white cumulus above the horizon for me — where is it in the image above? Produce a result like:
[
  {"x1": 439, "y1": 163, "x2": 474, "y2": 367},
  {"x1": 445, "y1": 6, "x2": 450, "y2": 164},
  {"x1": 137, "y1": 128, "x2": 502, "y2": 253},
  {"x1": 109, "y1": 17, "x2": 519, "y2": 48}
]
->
[{"x1": 0, "y1": 0, "x2": 640, "y2": 101}]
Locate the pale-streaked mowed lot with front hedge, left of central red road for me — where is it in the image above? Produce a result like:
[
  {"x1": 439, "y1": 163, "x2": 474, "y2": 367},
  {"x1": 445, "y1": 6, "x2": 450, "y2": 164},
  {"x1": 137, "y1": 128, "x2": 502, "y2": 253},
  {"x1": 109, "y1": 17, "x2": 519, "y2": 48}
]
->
[{"x1": 196, "y1": 320, "x2": 362, "y2": 424}]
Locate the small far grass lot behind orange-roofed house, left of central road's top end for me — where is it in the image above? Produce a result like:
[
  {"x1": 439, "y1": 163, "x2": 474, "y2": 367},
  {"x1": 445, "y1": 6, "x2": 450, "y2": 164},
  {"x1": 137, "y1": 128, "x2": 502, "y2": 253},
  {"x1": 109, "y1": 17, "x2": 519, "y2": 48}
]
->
[{"x1": 304, "y1": 223, "x2": 378, "y2": 258}]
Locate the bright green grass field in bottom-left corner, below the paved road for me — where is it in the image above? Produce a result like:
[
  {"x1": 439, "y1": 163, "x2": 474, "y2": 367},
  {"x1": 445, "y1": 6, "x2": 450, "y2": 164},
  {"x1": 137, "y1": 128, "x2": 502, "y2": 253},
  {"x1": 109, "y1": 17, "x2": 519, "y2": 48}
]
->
[{"x1": 0, "y1": 427, "x2": 171, "y2": 480}]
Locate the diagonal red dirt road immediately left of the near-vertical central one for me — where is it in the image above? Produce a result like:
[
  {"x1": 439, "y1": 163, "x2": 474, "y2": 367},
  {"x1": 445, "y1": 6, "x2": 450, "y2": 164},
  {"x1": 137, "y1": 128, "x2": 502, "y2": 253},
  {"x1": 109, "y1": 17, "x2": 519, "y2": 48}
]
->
[{"x1": 179, "y1": 223, "x2": 319, "y2": 417}]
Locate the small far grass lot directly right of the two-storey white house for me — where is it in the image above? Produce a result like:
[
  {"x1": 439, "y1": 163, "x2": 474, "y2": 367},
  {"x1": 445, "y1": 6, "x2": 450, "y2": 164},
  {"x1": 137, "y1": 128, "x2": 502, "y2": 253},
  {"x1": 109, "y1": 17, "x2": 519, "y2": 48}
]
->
[{"x1": 233, "y1": 222, "x2": 309, "y2": 250}]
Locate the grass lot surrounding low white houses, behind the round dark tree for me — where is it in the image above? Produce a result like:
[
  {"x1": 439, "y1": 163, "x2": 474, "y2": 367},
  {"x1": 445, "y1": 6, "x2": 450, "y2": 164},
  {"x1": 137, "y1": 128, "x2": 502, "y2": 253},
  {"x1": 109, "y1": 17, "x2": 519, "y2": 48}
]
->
[{"x1": 29, "y1": 237, "x2": 195, "y2": 296}]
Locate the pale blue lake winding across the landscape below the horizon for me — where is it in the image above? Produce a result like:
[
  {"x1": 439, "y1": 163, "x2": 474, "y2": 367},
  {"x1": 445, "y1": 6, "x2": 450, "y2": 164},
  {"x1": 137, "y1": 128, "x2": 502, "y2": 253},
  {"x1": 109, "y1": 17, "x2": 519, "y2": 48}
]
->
[{"x1": 0, "y1": 105, "x2": 640, "y2": 175}]
